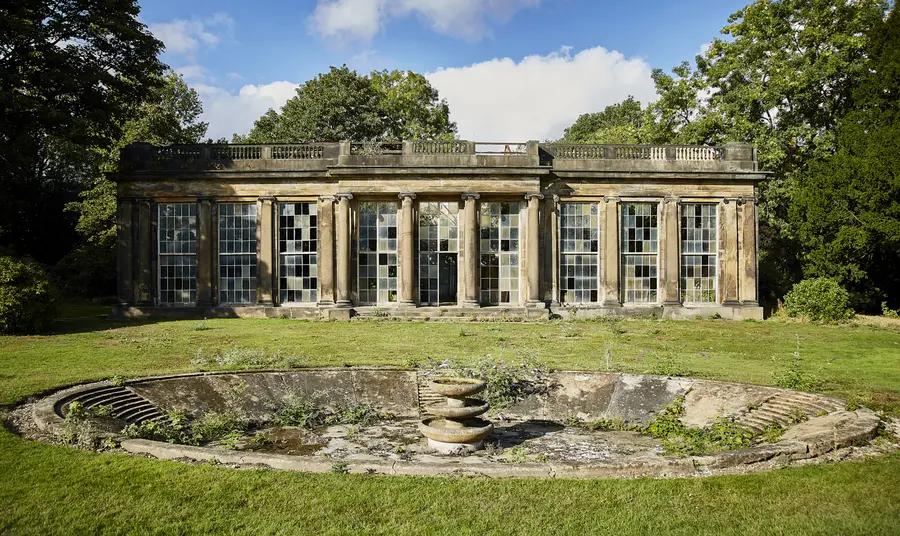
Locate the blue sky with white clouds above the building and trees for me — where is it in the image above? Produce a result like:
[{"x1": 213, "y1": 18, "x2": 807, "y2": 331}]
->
[{"x1": 140, "y1": 0, "x2": 749, "y2": 141}]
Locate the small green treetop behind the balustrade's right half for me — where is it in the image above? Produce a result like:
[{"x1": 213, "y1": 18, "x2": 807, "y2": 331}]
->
[{"x1": 560, "y1": 96, "x2": 648, "y2": 143}]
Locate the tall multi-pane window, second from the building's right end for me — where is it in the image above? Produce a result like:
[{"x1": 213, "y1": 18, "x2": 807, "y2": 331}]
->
[{"x1": 622, "y1": 203, "x2": 659, "y2": 303}]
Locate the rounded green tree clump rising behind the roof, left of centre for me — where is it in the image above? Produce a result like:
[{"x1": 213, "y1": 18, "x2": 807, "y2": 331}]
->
[{"x1": 241, "y1": 65, "x2": 456, "y2": 143}]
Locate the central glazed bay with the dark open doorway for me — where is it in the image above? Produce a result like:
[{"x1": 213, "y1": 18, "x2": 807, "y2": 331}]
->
[{"x1": 419, "y1": 202, "x2": 459, "y2": 305}]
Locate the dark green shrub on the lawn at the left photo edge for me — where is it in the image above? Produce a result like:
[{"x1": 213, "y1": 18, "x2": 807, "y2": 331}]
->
[{"x1": 0, "y1": 256, "x2": 56, "y2": 333}]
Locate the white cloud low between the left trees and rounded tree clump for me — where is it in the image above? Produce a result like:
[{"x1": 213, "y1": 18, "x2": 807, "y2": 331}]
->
[{"x1": 192, "y1": 81, "x2": 298, "y2": 140}]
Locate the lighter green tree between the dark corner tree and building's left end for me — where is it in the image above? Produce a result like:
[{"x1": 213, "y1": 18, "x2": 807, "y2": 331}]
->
[{"x1": 57, "y1": 72, "x2": 208, "y2": 297}]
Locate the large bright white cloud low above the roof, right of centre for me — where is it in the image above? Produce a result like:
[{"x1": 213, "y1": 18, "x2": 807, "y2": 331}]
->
[{"x1": 425, "y1": 47, "x2": 656, "y2": 141}]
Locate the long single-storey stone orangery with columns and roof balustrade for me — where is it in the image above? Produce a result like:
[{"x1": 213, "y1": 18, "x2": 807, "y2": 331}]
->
[{"x1": 111, "y1": 140, "x2": 767, "y2": 319}]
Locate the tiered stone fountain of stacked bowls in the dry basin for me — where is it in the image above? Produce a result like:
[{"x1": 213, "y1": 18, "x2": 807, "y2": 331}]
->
[{"x1": 419, "y1": 378, "x2": 494, "y2": 454}]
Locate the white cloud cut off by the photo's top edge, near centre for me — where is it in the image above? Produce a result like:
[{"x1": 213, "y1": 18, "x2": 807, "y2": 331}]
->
[{"x1": 307, "y1": 0, "x2": 541, "y2": 41}]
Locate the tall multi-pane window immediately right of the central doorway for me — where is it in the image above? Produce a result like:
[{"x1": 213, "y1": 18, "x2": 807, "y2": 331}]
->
[{"x1": 480, "y1": 202, "x2": 521, "y2": 305}]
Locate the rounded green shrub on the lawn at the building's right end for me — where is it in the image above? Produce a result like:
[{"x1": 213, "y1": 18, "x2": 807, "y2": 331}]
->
[{"x1": 784, "y1": 277, "x2": 853, "y2": 322}]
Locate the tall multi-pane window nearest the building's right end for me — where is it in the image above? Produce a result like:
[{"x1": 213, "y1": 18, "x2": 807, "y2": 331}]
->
[{"x1": 681, "y1": 203, "x2": 718, "y2": 303}]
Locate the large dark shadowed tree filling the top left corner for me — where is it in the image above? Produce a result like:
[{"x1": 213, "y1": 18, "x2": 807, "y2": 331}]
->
[{"x1": 0, "y1": 0, "x2": 164, "y2": 262}]
